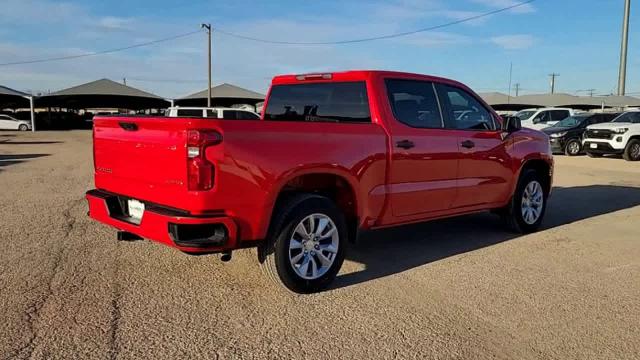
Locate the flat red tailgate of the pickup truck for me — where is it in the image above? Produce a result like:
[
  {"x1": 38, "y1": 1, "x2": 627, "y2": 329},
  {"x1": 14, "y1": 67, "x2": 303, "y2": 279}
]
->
[{"x1": 93, "y1": 117, "x2": 190, "y2": 208}]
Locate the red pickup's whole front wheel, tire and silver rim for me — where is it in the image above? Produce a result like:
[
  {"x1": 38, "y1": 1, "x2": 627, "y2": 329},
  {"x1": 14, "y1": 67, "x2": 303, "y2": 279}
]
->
[{"x1": 502, "y1": 169, "x2": 547, "y2": 234}]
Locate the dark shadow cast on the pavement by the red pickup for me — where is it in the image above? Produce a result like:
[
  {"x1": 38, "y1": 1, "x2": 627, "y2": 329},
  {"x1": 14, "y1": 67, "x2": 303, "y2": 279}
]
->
[{"x1": 332, "y1": 185, "x2": 640, "y2": 289}]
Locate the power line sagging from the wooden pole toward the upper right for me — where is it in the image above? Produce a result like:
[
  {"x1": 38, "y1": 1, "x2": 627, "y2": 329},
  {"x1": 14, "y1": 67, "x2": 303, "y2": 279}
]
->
[{"x1": 214, "y1": 0, "x2": 536, "y2": 45}]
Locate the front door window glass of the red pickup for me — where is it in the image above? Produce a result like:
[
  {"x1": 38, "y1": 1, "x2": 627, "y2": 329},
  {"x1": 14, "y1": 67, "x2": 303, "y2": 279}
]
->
[{"x1": 438, "y1": 84, "x2": 496, "y2": 130}]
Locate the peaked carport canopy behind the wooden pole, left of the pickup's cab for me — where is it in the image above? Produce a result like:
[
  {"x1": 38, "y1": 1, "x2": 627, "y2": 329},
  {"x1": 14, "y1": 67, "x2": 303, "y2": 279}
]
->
[{"x1": 175, "y1": 83, "x2": 265, "y2": 106}]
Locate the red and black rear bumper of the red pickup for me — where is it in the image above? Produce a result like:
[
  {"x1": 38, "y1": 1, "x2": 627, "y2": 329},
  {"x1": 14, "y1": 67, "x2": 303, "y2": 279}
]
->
[{"x1": 86, "y1": 190, "x2": 240, "y2": 253}]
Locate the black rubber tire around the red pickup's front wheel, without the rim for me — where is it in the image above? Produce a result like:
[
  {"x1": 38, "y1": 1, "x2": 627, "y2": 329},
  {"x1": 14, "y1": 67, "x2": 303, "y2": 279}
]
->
[{"x1": 500, "y1": 169, "x2": 548, "y2": 234}]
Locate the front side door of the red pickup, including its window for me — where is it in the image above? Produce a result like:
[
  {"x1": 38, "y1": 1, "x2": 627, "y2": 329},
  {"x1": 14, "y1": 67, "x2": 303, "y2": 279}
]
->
[{"x1": 438, "y1": 84, "x2": 513, "y2": 208}]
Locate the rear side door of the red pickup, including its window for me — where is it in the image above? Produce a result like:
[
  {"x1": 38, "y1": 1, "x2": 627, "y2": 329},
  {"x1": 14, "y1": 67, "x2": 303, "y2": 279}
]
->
[{"x1": 385, "y1": 79, "x2": 458, "y2": 217}]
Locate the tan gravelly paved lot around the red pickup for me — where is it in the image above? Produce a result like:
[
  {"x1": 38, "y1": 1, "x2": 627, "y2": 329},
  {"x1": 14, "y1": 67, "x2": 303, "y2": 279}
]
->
[{"x1": 0, "y1": 131, "x2": 640, "y2": 359}]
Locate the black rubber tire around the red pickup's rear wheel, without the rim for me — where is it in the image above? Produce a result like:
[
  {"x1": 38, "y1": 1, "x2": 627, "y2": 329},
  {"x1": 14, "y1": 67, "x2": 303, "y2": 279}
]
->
[{"x1": 258, "y1": 194, "x2": 348, "y2": 294}]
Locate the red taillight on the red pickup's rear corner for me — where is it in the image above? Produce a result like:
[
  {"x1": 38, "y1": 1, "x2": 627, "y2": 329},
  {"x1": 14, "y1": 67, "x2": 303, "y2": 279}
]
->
[{"x1": 187, "y1": 130, "x2": 222, "y2": 191}]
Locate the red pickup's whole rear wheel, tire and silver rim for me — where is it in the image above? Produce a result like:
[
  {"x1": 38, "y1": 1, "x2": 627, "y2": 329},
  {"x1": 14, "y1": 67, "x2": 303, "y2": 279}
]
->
[{"x1": 258, "y1": 194, "x2": 348, "y2": 293}]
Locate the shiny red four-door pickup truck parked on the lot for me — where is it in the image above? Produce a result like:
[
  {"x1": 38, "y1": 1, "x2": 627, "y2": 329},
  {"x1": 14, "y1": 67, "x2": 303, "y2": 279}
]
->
[{"x1": 87, "y1": 71, "x2": 553, "y2": 293}]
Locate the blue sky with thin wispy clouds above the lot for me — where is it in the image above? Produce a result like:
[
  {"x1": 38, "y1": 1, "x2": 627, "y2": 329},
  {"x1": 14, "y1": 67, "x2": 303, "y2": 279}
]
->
[{"x1": 0, "y1": 0, "x2": 640, "y2": 98}]
